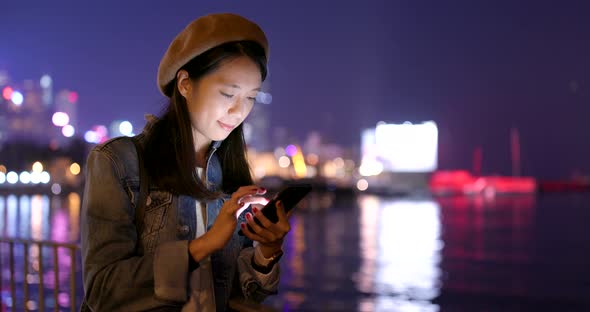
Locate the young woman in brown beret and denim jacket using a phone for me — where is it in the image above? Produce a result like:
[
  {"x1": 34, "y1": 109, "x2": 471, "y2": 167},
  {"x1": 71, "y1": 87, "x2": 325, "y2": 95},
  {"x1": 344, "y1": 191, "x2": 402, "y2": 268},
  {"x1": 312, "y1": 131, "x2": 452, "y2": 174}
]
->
[{"x1": 81, "y1": 14, "x2": 290, "y2": 311}]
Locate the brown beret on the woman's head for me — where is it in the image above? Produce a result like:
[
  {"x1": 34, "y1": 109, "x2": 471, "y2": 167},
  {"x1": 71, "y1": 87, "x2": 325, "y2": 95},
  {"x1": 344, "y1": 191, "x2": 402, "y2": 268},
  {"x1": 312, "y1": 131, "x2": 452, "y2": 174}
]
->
[{"x1": 158, "y1": 13, "x2": 268, "y2": 95}]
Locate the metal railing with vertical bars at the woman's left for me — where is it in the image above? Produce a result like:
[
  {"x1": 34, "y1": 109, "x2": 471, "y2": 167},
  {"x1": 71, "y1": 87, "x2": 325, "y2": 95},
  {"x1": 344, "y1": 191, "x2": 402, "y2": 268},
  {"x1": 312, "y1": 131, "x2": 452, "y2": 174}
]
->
[{"x1": 0, "y1": 237, "x2": 80, "y2": 312}]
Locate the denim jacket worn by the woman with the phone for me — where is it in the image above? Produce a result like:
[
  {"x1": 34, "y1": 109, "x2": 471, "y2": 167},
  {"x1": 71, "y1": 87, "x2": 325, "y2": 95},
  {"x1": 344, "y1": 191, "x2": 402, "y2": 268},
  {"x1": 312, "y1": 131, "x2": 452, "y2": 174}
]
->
[{"x1": 81, "y1": 133, "x2": 279, "y2": 311}]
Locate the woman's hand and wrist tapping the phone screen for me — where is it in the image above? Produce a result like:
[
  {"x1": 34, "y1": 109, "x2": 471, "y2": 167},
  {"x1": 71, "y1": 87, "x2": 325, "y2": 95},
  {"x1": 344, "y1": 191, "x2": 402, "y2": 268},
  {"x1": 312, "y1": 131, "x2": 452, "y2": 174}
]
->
[{"x1": 189, "y1": 185, "x2": 268, "y2": 262}]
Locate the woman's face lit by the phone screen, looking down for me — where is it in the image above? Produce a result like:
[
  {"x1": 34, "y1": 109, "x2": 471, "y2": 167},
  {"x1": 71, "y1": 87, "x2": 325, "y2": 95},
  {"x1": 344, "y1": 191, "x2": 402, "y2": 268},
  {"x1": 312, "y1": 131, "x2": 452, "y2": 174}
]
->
[{"x1": 179, "y1": 56, "x2": 262, "y2": 145}]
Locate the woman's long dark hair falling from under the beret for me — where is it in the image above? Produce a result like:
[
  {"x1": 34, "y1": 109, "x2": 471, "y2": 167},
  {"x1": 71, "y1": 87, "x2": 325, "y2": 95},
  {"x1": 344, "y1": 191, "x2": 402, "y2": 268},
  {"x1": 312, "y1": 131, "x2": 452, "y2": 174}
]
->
[{"x1": 144, "y1": 41, "x2": 267, "y2": 200}]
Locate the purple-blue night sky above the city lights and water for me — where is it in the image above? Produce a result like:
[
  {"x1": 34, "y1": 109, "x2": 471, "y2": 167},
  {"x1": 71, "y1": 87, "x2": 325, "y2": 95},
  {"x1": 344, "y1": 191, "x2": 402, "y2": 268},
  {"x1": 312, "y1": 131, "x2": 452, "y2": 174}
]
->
[{"x1": 0, "y1": 0, "x2": 590, "y2": 178}]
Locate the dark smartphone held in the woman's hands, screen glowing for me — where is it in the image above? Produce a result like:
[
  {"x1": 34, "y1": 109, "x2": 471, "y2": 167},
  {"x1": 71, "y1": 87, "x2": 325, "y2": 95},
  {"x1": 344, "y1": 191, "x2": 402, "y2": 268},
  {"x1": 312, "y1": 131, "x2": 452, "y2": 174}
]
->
[{"x1": 239, "y1": 184, "x2": 312, "y2": 235}]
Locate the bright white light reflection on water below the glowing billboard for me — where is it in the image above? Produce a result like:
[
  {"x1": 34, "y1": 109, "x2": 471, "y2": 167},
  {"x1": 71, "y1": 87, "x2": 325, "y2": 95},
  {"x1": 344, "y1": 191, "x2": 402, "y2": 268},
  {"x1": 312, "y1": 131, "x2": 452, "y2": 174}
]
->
[{"x1": 356, "y1": 196, "x2": 442, "y2": 311}]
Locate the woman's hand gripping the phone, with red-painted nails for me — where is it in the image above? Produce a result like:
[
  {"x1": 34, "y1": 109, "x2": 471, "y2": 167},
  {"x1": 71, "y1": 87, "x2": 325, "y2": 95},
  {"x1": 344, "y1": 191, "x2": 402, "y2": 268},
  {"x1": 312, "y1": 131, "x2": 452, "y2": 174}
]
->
[{"x1": 240, "y1": 201, "x2": 293, "y2": 257}]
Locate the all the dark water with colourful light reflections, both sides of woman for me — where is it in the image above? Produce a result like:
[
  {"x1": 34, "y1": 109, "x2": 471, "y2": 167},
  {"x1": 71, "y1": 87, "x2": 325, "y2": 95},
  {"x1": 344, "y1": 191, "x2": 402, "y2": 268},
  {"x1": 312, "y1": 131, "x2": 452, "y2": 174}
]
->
[{"x1": 0, "y1": 193, "x2": 590, "y2": 311}]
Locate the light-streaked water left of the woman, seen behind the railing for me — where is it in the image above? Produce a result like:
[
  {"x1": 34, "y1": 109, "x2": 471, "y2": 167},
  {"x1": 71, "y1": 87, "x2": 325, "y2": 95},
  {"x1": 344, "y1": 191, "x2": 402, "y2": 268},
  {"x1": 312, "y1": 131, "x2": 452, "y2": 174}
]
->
[{"x1": 0, "y1": 193, "x2": 82, "y2": 310}]
